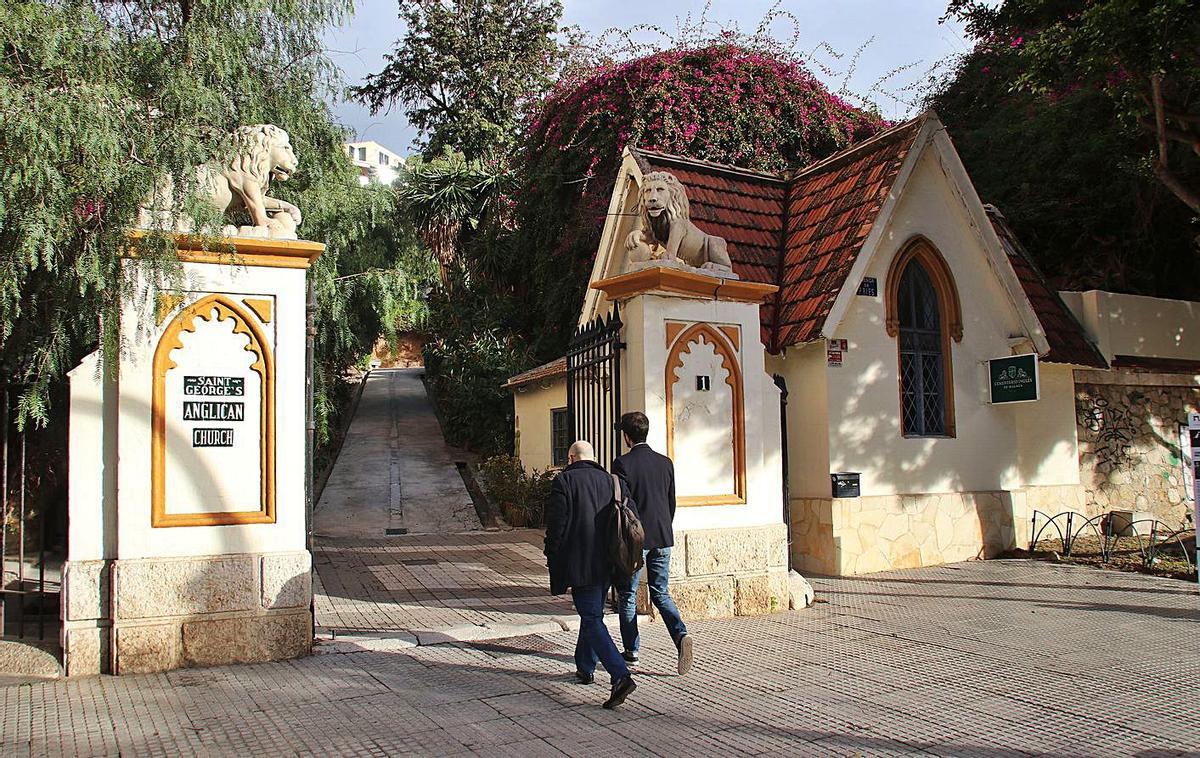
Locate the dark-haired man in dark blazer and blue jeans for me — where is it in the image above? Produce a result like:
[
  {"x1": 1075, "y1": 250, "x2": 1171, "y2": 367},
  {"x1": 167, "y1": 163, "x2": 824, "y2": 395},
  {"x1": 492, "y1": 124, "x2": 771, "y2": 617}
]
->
[{"x1": 612, "y1": 411, "x2": 692, "y2": 675}]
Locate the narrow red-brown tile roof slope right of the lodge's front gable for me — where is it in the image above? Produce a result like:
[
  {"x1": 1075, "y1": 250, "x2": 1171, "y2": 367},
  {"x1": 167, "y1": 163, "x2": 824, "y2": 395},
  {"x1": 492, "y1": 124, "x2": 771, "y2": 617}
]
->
[{"x1": 984, "y1": 205, "x2": 1108, "y2": 368}]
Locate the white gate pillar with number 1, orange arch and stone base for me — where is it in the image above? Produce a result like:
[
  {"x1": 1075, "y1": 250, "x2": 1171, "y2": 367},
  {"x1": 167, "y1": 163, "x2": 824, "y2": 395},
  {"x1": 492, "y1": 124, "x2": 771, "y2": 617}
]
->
[{"x1": 592, "y1": 266, "x2": 788, "y2": 618}]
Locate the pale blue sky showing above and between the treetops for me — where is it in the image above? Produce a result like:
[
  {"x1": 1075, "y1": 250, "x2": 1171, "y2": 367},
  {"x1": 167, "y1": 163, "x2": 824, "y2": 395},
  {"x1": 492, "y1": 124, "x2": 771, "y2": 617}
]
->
[{"x1": 325, "y1": 0, "x2": 968, "y2": 155}]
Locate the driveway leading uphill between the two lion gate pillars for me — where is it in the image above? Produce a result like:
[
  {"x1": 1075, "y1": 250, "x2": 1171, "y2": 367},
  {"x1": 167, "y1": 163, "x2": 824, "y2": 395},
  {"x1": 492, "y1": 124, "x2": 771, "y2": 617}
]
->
[{"x1": 313, "y1": 369, "x2": 577, "y2": 646}]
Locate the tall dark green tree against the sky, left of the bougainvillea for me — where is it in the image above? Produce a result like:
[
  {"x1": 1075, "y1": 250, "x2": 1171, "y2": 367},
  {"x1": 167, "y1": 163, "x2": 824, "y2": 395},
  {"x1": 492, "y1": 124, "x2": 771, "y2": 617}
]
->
[{"x1": 353, "y1": 0, "x2": 563, "y2": 158}]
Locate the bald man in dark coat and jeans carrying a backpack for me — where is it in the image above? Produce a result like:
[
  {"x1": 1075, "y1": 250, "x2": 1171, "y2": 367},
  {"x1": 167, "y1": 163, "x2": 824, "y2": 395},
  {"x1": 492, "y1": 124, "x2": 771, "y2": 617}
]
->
[{"x1": 546, "y1": 440, "x2": 637, "y2": 709}]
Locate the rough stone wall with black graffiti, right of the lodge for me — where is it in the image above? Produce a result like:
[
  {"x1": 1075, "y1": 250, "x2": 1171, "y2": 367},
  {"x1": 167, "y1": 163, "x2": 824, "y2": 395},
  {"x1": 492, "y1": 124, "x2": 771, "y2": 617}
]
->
[{"x1": 1075, "y1": 372, "x2": 1200, "y2": 528}]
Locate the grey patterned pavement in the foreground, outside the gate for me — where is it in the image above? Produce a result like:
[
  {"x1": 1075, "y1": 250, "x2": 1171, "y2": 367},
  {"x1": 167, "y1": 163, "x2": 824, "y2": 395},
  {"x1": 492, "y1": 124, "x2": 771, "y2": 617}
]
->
[{"x1": 0, "y1": 561, "x2": 1200, "y2": 758}]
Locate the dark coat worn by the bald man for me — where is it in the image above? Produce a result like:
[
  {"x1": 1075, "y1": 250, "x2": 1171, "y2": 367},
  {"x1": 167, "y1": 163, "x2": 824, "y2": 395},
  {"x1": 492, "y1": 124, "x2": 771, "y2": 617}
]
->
[{"x1": 545, "y1": 461, "x2": 613, "y2": 595}]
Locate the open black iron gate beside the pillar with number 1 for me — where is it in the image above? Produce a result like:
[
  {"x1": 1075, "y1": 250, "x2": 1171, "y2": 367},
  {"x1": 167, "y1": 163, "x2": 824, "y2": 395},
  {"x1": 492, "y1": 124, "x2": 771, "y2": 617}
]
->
[{"x1": 566, "y1": 306, "x2": 625, "y2": 467}]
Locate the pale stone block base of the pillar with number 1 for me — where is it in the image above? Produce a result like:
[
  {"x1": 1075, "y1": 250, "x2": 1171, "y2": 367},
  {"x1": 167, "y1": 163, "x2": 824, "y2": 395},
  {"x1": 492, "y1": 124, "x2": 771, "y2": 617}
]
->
[{"x1": 638, "y1": 523, "x2": 788, "y2": 620}]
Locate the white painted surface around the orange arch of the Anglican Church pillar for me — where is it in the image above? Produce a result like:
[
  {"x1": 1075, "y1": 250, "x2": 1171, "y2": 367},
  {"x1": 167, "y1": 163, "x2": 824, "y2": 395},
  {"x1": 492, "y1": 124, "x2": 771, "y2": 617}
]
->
[{"x1": 112, "y1": 261, "x2": 305, "y2": 559}]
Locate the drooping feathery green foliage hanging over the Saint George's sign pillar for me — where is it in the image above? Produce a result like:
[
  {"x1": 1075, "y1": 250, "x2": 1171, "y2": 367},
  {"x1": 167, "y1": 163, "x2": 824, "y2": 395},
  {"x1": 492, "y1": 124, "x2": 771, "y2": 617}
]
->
[{"x1": 0, "y1": 0, "x2": 434, "y2": 434}]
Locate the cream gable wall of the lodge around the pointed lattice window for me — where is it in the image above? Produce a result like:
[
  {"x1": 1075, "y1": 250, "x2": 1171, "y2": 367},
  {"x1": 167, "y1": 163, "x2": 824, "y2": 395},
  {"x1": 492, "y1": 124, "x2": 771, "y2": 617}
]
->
[{"x1": 782, "y1": 150, "x2": 1079, "y2": 497}]
